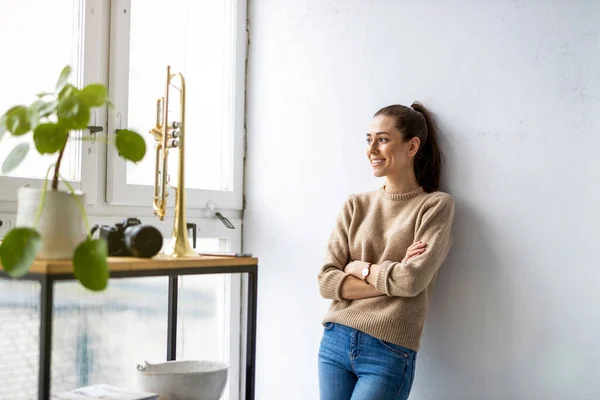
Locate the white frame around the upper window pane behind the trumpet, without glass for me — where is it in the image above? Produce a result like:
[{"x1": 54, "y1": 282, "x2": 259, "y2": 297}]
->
[{"x1": 106, "y1": 0, "x2": 247, "y2": 210}]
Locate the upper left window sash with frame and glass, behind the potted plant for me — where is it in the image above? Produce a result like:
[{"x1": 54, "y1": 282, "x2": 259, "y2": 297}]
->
[{"x1": 0, "y1": 0, "x2": 98, "y2": 203}]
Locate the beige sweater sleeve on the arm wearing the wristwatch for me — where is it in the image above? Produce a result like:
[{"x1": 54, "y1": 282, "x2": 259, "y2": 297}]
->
[{"x1": 375, "y1": 194, "x2": 454, "y2": 297}]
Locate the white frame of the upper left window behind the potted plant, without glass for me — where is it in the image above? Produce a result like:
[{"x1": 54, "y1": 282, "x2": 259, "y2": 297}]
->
[{"x1": 0, "y1": 0, "x2": 107, "y2": 204}]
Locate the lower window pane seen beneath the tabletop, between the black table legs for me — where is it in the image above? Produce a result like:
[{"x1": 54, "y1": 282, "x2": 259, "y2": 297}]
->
[{"x1": 52, "y1": 277, "x2": 168, "y2": 392}]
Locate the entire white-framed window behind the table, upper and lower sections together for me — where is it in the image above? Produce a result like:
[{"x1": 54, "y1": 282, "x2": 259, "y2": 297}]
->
[{"x1": 0, "y1": 0, "x2": 247, "y2": 400}]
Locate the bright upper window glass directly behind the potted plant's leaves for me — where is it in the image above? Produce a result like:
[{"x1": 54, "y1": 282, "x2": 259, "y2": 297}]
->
[{"x1": 0, "y1": 0, "x2": 83, "y2": 180}]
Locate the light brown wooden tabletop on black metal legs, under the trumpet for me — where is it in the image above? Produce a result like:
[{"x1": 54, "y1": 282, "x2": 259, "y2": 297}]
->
[{"x1": 0, "y1": 256, "x2": 258, "y2": 274}]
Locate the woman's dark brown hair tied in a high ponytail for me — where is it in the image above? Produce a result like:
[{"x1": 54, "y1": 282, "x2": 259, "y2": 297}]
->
[{"x1": 374, "y1": 101, "x2": 442, "y2": 193}]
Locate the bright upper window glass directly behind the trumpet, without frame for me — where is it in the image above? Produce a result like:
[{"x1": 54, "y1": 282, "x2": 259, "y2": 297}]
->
[{"x1": 127, "y1": 0, "x2": 234, "y2": 190}]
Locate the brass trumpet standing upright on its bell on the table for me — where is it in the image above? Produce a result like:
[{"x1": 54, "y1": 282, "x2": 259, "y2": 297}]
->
[{"x1": 150, "y1": 66, "x2": 199, "y2": 258}]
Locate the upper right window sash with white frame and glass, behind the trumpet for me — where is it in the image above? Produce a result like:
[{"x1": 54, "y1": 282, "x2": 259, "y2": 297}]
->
[{"x1": 107, "y1": 0, "x2": 246, "y2": 209}]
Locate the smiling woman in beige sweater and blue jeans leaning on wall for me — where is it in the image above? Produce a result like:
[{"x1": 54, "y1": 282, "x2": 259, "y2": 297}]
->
[{"x1": 319, "y1": 103, "x2": 454, "y2": 400}]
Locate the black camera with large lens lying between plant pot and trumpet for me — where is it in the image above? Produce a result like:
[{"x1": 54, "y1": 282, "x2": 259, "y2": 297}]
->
[{"x1": 98, "y1": 218, "x2": 163, "y2": 258}]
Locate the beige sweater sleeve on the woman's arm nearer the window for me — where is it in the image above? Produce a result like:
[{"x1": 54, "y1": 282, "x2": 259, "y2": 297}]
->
[{"x1": 318, "y1": 197, "x2": 353, "y2": 300}]
